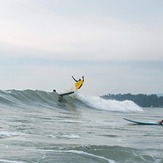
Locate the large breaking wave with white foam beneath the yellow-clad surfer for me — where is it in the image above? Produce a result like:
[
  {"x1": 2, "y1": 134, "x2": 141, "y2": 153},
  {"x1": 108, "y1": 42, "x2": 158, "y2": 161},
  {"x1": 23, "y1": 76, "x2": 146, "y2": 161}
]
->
[{"x1": 0, "y1": 90, "x2": 143, "y2": 112}]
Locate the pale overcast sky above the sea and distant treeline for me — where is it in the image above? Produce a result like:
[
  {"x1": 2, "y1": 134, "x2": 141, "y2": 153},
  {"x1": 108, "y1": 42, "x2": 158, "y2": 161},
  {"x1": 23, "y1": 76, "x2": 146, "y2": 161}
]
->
[{"x1": 0, "y1": 0, "x2": 163, "y2": 95}]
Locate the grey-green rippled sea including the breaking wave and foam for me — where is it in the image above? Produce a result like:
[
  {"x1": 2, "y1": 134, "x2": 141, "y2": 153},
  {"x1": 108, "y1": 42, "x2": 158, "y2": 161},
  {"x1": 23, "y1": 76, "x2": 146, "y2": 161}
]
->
[{"x1": 0, "y1": 90, "x2": 163, "y2": 163}]
